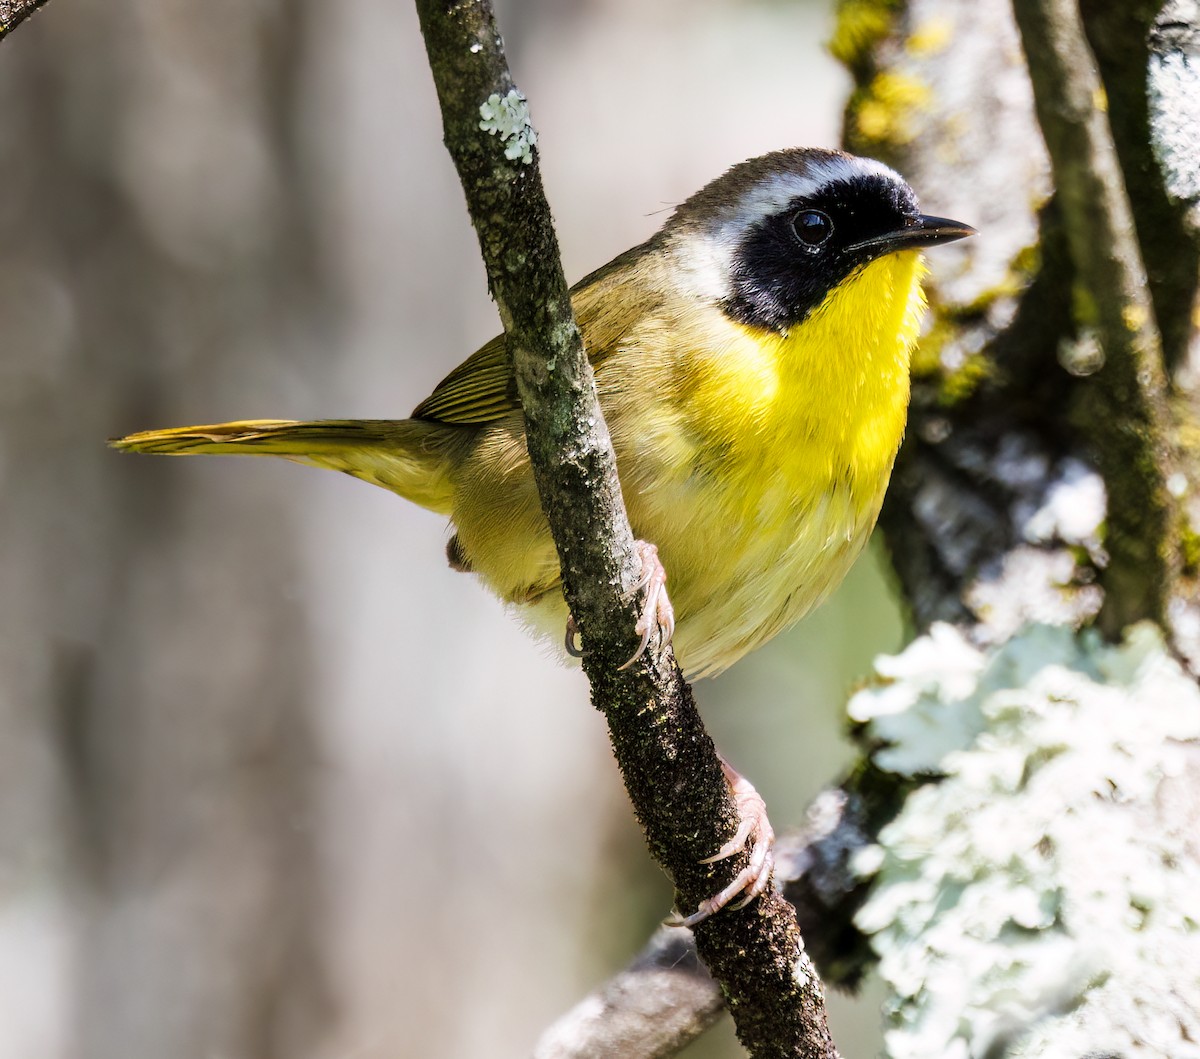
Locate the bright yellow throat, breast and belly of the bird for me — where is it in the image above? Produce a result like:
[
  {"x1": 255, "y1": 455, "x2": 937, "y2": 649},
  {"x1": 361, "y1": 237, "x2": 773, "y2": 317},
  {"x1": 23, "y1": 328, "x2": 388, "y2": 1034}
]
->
[{"x1": 614, "y1": 252, "x2": 924, "y2": 676}]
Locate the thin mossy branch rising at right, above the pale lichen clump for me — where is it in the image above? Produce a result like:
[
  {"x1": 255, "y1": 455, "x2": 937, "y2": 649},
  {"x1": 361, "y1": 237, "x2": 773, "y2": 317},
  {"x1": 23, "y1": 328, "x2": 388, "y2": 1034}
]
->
[{"x1": 1013, "y1": 0, "x2": 1180, "y2": 635}]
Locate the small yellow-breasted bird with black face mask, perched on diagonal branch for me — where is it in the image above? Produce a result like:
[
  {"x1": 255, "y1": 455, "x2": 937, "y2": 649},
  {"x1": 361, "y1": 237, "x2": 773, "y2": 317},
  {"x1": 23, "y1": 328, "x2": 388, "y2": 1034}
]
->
[{"x1": 110, "y1": 148, "x2": 976, "y2": 922}]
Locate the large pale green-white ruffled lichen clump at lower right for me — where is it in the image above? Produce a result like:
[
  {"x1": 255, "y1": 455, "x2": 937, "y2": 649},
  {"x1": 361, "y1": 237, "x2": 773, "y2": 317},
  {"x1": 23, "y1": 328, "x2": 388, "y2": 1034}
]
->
[{"x1": 851, "y1": 626, "x2": 1200, "y2": 1059}]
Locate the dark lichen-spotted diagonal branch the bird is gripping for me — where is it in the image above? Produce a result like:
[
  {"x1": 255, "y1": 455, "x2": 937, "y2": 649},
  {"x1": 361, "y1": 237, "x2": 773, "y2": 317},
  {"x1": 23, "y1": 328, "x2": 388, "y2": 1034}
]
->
[{"x1": 416, "y1": 0, "x2": 836, "y2": 1059}]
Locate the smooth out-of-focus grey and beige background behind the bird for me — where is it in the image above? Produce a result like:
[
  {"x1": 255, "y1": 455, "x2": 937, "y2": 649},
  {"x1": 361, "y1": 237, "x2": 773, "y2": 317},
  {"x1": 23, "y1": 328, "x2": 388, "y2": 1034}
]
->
[{"x1": 0, "y1": 0, "x2": 902, "y2": 1059}]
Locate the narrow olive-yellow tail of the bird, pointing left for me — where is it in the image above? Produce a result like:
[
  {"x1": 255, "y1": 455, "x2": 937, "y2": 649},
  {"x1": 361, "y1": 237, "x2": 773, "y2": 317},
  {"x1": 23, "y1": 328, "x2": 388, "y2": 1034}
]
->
[{"x1": 109, "y1": 419, "x2": 467, "y2": 514}]
